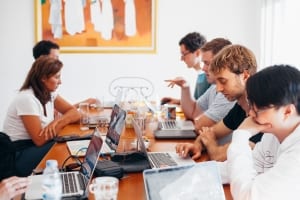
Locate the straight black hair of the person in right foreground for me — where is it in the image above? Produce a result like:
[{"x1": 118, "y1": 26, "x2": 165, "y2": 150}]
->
[{"x1": 246, "y1": 65, "x2": 300, "y2": 114}]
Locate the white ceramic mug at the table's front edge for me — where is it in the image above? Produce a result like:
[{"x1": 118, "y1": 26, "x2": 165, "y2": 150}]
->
[{"x1": 89, "y1": 176, "x2": 119, "y2": 200}]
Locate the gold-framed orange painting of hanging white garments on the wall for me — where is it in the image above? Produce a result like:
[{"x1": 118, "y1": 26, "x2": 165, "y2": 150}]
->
[{"x1": 35, "y1": 0, "x2": 157, "y2": 53}]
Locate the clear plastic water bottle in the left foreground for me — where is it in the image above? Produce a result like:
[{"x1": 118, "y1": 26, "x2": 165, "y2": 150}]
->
[{"x1": 43, "y1": 160, "x2": 62, "y2": 200}]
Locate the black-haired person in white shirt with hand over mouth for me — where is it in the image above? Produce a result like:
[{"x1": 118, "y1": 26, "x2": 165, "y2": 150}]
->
[{"x1": 223, "y1": 65, "x2": 300, "y2": 200}]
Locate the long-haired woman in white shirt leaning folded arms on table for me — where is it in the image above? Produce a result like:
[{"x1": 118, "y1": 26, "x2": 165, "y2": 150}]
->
[{"x1": 3, "y1": 56, "x2": 80, "y2": 176}]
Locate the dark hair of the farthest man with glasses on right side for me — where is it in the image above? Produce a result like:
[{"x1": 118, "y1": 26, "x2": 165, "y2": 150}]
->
[{"x1": 179, "y1": 32, "x2": 206, "y2": 53}]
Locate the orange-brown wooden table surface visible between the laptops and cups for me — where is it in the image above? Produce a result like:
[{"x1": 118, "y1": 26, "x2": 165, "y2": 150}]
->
[{"x1": 37, "y1": 110, "x2": 232, "y2": 200}]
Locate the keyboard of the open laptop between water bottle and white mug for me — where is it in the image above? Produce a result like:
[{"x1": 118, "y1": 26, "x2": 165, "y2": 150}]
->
[{"x1": 61, "y1": 173, "x2": 85, "y2": 194}]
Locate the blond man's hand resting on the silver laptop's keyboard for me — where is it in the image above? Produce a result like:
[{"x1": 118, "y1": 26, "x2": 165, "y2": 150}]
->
[{"x1": 175, "y1": 143, "x2": 202, "y2": 160}]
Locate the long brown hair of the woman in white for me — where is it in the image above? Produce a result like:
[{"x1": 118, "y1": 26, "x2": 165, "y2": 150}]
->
[{"x1": 20, "y1": 56, "x2": 63, "y2": 111}]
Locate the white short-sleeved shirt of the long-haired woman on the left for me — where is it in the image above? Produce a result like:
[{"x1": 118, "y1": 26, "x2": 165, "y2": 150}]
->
[{"x1": 3, "y1": 89, "x2": 57, "y2": 141}]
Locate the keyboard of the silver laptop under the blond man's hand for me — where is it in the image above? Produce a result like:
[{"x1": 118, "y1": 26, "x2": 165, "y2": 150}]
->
[{"x1": 148, "y1": 153, "x2": 177, "y2": 168}]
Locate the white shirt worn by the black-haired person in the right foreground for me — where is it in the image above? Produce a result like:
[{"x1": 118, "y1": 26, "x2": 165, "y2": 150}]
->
[{"x1": 220, "y1": 126, "x2": 300, "y2": 200}]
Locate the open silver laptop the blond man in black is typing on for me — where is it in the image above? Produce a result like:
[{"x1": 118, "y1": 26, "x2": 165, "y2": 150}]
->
[{"x1": 132, "y1": 119, "x2": 195, "y2": 168}]
